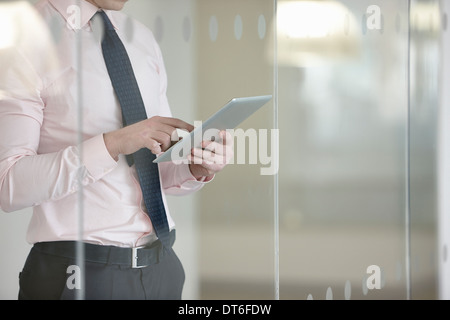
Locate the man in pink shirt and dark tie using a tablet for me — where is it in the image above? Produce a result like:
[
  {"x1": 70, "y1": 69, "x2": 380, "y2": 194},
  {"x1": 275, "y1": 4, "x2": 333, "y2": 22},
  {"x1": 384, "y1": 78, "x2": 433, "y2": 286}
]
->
[{"x1": 0, "y1": 0, "x2": 232, "y2": 299}]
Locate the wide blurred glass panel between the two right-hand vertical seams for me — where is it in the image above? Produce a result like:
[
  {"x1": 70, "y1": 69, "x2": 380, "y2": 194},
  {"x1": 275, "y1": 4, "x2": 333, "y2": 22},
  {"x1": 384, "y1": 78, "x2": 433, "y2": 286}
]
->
[{"x1": 277, "y1": 0, "x2": 409, "y2": 299}]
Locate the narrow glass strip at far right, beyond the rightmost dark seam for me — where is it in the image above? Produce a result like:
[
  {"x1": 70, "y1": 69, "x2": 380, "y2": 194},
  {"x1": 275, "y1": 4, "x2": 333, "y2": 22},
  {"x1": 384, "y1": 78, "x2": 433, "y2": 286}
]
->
[{"x1": 409, "y1": 0, "x2": 445, "y2": 299}]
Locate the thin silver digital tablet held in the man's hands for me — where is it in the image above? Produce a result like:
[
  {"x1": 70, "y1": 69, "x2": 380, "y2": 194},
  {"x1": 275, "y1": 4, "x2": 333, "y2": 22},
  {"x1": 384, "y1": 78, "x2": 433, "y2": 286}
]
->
[{"x1": 153, "y1": 95, "x2": 272, "y2": 163}]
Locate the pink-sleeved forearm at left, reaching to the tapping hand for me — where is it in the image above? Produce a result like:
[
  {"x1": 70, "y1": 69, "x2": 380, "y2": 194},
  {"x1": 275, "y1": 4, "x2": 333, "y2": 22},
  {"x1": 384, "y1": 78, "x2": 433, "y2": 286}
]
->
[{"x1": 0, "y1": 137, "x2": 115, "y2": 212}]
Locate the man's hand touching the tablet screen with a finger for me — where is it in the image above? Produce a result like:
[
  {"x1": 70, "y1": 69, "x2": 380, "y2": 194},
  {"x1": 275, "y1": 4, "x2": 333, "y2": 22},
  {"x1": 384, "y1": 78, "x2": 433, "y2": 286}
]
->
[{"x1": 103, "y1": 116, "x2": 194, "y2": 161}]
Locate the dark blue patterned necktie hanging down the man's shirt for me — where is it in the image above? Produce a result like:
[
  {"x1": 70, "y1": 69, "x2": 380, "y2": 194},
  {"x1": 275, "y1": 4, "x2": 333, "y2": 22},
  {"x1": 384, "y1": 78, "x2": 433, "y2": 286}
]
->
[{"x1": 97, "y1": 11, "x2": 170, "y2": 248}]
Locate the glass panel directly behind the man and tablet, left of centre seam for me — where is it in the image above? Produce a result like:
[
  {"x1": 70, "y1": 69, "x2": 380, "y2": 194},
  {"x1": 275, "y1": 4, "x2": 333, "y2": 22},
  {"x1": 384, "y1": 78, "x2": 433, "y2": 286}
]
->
[{"x1": 127, "y1": 0, "x2": 277, "y2": 299}]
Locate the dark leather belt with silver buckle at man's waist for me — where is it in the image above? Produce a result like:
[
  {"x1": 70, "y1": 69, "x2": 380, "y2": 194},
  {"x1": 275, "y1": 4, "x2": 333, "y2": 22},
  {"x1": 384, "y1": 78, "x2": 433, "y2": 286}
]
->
[{"x1": 33, "y1": 230, "x2": 175, "y2": 268}]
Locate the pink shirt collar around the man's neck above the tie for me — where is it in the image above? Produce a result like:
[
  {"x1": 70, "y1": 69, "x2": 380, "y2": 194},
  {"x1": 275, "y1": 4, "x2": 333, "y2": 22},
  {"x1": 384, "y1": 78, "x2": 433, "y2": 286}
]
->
[{"x1": 48, "y1": 0, "x2": 118, "y2": 30}]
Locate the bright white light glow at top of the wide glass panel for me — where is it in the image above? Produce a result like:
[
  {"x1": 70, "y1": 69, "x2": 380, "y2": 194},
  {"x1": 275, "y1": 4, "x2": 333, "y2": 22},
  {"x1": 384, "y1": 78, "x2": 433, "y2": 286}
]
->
[{"x1": 277, "y1": 1, "x2": 360, "y2": 67}]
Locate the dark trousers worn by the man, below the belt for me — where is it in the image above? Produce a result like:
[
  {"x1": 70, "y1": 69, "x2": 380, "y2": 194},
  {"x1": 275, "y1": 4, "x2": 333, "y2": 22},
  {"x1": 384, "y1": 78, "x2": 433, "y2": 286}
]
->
[{"x1": 18, "y1": 242, "x2": 185, "y2": 300}]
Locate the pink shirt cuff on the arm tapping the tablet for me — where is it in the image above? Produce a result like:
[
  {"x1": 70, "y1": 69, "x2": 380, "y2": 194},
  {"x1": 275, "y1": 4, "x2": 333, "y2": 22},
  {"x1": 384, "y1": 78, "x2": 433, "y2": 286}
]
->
[{"x1": 80, "y1": 134, "x2": 117, "y2": 180}]
